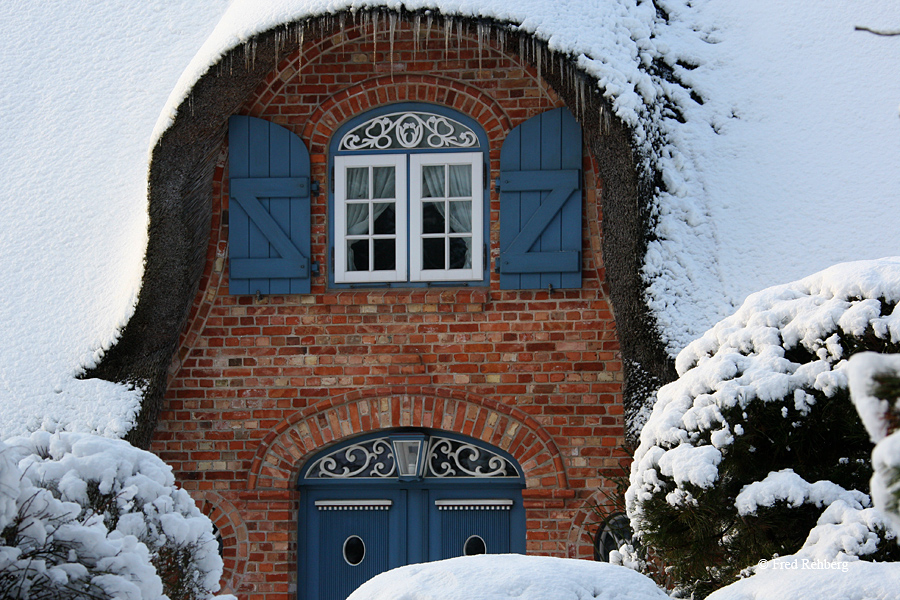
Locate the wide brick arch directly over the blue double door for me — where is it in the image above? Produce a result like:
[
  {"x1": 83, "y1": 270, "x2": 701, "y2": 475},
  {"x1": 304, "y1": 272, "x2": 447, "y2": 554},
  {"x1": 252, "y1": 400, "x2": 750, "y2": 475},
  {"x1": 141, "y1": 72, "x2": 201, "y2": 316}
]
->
[{"x1": 247, "y1": 386, "x2": 568, "y2": 490}]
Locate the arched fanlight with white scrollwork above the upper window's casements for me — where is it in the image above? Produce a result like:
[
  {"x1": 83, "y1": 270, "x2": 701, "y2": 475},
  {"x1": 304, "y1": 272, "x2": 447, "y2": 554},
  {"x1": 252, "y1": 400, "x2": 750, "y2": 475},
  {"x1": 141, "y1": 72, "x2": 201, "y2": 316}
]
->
[{"x1": 338, "y1": 112, "x2": 478, "y2": 150}]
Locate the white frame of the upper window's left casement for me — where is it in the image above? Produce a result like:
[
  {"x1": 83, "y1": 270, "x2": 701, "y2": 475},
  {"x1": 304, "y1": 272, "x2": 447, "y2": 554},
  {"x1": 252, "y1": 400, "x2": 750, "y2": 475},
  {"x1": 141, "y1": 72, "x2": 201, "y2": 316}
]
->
[{"x1": 334, "y1": 154, "x2": 409, "y2": 283}]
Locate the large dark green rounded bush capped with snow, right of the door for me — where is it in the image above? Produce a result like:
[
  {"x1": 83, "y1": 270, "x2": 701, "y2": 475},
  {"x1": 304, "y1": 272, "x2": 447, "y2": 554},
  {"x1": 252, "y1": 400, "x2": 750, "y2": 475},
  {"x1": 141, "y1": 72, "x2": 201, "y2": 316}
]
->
[{"x1": 626, "y1": 259, "x2": 900, "y2": 597}]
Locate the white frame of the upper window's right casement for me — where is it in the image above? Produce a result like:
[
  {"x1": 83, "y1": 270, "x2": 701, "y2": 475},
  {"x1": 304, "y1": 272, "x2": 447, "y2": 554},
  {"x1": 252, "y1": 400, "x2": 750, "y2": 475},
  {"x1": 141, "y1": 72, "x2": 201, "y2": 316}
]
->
[{"x1": 409, "y1": 152, "x2": 484, "y2": 282}]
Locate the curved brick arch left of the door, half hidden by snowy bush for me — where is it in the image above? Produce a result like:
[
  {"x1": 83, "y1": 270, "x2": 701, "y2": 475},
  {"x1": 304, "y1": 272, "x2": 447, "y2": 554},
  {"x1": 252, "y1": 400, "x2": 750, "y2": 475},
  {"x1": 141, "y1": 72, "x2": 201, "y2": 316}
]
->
[{"x1": 191, "y1": 490, "x2": 250, "y2": 594}]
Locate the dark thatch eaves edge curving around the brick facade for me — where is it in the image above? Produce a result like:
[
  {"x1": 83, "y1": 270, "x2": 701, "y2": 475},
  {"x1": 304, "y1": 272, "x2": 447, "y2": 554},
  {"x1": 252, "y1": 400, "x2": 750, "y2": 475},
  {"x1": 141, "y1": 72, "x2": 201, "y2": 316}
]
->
[{"x1": 85, "y1": 10, "x2": 674, "y2": 447}]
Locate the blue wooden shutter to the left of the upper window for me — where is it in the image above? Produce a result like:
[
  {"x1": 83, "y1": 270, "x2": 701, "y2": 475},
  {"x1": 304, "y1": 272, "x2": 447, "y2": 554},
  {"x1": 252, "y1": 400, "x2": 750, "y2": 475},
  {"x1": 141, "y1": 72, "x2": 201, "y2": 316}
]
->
[{"x1": 228, "y1": 116, "x2": 311, "y2": 294}]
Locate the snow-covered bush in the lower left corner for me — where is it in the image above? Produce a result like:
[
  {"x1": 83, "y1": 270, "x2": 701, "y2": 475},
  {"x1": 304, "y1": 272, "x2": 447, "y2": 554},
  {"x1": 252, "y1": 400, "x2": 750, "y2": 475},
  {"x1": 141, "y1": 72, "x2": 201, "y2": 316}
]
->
[{"x1": 0, "y1": 432, "x2": 222, "y2": 600}]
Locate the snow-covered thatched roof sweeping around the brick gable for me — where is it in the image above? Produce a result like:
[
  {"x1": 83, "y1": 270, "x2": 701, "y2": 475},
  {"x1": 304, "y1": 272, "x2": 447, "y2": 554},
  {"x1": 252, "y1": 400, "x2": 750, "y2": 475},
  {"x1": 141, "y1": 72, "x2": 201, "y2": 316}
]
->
[{"x1": 0, "y1": 0, "x2": 900, "y2": 437}]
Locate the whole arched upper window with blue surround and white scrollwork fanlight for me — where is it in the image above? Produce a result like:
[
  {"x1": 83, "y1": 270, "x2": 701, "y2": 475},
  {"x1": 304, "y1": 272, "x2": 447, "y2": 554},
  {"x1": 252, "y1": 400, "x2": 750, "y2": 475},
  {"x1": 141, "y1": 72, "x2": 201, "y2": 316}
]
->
[{"x1": 331, "y1": 107, "x2": 487, "y2": 285}]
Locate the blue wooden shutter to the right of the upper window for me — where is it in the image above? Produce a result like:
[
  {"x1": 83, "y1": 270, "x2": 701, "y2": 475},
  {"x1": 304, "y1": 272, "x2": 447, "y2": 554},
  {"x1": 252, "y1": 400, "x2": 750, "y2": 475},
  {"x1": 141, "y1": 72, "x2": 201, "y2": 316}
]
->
[{"x1": 497, "y1": 108, "x2": 581, "y2": 289}]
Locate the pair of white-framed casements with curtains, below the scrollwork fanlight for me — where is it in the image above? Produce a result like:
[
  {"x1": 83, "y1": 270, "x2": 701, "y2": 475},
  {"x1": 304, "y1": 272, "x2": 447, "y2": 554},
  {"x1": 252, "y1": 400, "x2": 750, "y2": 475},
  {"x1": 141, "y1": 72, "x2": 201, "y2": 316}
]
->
[{"x1": 335, "y1": 152, "x2": 484, "y2": 283}]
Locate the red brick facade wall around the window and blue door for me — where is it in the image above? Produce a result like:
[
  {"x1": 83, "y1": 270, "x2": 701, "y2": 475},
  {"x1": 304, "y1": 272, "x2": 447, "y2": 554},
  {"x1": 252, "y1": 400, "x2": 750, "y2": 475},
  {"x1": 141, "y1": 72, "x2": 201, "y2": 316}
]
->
[{"x1": 152, "y1": 22, "x2": 624, "y2": 600}]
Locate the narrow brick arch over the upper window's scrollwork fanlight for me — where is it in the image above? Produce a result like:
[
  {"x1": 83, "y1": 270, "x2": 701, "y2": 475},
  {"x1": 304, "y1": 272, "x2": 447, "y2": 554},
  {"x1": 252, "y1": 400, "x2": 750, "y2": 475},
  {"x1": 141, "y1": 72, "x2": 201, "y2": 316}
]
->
[{"x1": 302, "y1": 74, "x2": 512, "y2": 155}]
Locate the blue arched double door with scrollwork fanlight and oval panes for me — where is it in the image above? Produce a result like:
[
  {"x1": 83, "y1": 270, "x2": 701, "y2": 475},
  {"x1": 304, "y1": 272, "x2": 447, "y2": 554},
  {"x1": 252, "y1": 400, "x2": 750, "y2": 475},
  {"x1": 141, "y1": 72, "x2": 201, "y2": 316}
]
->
[{"x1": 297, "y1": 430, "x2": 525, "y2": 600}]
